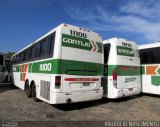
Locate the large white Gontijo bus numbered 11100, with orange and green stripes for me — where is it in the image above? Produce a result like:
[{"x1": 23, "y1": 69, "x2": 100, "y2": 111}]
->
[{"x1": 11, "y1": 24, "x2": 103, "y2": 104}]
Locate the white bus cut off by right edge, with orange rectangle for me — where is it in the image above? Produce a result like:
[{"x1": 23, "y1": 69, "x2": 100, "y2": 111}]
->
[{"x1": 139, "y1": 42, "x2": 160, "y2": 95}]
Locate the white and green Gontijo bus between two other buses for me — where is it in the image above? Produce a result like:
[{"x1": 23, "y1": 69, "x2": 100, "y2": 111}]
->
[{"x1": 102, "y1": 38, "x2": 141, "y2": 99}]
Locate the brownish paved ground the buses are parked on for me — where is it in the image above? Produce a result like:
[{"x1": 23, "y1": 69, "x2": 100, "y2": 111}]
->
[{"x1": 0, "y1": 84, "x2": 160, "y2": 125}]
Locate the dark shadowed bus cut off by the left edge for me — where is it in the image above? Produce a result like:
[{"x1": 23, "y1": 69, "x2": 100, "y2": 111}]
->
[{"x1": 0, "y1": 52, "x2": 8, "y2": 83}]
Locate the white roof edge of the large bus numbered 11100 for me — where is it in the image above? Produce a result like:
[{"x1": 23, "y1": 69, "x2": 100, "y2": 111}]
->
[{"x1": 12, "y1": 23, "x2": 101, "y2": 57}]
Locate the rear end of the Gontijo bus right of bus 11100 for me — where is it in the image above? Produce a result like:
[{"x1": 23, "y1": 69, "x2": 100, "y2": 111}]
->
[{"x1": 113, "y1": 39, "x2": 141, "y2": 98}]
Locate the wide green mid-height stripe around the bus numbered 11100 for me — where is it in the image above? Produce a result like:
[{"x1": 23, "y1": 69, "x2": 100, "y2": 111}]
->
[{"x1": 13, "y1": 59, "x2": 103, "y2": 76}]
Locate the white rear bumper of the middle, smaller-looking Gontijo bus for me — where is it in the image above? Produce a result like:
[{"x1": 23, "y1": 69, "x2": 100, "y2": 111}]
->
[{"x1": 108, "y1": 88, "x2": 141, "y2": 99}]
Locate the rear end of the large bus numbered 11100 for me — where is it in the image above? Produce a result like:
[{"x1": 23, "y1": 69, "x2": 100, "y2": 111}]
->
[{"x1": 52, "y1": 24, "x2": 103, "y2": 103}]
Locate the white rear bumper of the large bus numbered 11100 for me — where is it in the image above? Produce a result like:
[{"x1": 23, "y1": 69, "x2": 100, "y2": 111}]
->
[{"x1": 50, "y1": 88, "x2": 103, "y2": 104}]
